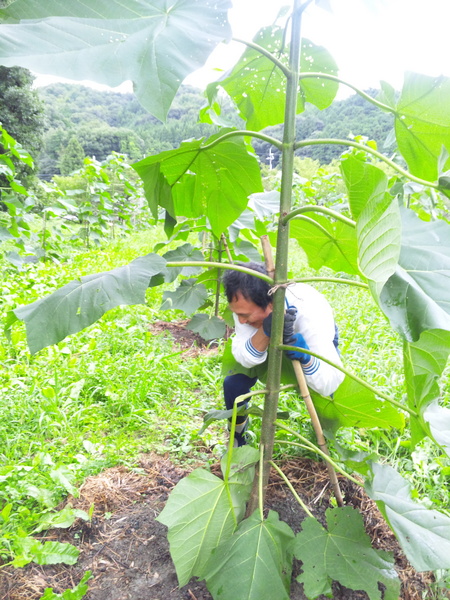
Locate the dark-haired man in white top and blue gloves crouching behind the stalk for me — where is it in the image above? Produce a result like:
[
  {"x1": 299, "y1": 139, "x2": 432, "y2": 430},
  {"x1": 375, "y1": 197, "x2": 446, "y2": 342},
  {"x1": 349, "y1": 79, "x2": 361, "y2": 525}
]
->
[{"x1": 223, "y1": 262, "x2": 344, "y2": 446}]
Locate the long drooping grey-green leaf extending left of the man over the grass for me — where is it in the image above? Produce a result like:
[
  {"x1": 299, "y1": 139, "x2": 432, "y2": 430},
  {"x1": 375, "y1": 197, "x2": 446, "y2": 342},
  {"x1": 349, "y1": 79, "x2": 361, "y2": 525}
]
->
[{"x1": 14, "y1": 254, "x2": 166, "y2": 354}]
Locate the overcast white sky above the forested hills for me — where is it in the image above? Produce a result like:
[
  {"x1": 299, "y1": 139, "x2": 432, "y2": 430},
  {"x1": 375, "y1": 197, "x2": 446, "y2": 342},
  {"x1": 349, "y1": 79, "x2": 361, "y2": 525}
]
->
[{"x1": 38, "y1": 0, "x2": 450, "y2": 97}]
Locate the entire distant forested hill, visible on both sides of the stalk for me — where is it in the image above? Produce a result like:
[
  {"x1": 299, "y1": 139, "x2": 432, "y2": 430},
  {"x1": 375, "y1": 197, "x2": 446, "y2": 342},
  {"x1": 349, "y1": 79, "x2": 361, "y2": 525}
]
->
[{"x1": 38, "y1": 83, "x2": 393, "y2": 178}]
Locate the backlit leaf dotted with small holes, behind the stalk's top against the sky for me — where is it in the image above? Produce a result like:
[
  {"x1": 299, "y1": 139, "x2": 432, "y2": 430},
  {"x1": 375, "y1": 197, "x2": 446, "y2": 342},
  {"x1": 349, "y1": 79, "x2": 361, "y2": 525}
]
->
[{"x1": 208, "y1": 26, "x2": 338, "y2": 131}]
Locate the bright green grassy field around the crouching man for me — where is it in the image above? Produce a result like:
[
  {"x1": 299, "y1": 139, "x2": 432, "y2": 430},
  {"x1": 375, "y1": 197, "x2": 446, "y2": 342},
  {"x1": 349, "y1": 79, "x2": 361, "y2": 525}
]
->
[{"x1": 0, "y1": 228, "x2": 450, "y2": 559}]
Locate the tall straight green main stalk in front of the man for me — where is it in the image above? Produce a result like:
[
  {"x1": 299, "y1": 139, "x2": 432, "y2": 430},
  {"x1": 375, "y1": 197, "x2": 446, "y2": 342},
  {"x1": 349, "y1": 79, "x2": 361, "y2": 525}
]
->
[{"x1": 247, "y1": 0, "x2": 309, "y2": 514}]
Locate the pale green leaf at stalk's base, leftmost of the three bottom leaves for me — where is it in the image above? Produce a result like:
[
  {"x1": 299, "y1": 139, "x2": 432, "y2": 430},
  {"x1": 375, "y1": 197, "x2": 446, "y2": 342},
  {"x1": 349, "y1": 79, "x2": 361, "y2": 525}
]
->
[{"x1": 157, "y1": 447, "x2": 258, "y2": 586}]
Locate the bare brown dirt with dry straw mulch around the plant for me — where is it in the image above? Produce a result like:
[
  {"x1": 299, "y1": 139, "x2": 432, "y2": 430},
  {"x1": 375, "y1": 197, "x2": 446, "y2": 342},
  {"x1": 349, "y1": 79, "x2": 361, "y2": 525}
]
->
[{"x1": 0, "y1": 322, "x2": 438, "y2": 600}]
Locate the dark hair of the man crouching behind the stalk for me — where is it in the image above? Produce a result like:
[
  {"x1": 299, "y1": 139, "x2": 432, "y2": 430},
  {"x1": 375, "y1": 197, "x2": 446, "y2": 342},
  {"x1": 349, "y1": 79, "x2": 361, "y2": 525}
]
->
[{"x1": 222, "y1": 262, "x2": 272, "y2": 308}]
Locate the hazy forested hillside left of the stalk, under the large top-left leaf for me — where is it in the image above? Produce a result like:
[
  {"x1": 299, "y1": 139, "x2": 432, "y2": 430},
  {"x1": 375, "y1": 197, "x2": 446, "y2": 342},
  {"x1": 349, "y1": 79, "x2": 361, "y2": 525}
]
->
[{"x1": 38, "y1": 83, "x2": 215, "y2": 178}]
